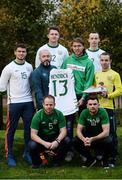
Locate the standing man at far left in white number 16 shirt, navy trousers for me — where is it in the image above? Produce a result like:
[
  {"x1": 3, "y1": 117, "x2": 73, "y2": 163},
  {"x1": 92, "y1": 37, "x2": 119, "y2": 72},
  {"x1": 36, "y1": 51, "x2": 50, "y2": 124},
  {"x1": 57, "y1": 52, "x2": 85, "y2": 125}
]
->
[{"x1": 0, "y1": 44, "x2": 34, "y2": 166}]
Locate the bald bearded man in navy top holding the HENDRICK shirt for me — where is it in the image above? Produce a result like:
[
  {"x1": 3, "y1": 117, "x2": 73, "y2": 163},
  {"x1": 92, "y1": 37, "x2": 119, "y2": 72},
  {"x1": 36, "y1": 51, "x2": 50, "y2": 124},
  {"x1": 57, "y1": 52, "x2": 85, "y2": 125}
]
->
[{"x1": 31, "y1": 49, "x2": 56, "y2": 110}]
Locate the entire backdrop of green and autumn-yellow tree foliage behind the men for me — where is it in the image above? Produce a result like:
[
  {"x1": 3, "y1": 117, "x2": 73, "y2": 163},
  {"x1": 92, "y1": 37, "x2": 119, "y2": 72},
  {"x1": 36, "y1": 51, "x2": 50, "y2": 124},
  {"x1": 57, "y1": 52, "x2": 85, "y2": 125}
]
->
[{"x1": 0, "y1": 0, "x2": 122, "y2": 74}]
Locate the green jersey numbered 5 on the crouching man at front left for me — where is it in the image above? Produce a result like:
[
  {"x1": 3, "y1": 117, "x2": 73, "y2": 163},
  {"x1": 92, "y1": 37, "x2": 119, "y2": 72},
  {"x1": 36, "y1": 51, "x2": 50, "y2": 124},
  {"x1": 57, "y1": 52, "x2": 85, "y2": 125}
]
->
[{"x1": 31, "y1": 109, "x2": 66, "y2": 140}]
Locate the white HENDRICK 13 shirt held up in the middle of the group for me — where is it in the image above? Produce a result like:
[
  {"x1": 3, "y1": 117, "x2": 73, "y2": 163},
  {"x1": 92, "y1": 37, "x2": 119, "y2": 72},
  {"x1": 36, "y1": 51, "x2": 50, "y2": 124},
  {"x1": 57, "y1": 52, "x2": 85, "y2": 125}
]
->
[{"x1": 49, "y1": 69, "x2": 78, "y2": 116}]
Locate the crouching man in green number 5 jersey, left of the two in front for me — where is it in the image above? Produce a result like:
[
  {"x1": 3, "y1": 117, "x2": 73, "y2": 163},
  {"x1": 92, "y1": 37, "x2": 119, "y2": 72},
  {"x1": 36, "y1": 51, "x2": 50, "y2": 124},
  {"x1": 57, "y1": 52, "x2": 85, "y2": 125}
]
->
[{"x1": 29, "y1": 95, "x2": 70, "y2": 168}]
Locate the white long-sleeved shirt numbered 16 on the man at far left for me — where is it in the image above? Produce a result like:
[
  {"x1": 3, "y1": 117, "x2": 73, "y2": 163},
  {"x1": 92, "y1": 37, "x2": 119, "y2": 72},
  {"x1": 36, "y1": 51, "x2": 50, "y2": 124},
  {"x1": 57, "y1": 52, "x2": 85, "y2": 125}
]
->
[{"x1": 0, "y1": 61, "x2": 33, "y2": 104}]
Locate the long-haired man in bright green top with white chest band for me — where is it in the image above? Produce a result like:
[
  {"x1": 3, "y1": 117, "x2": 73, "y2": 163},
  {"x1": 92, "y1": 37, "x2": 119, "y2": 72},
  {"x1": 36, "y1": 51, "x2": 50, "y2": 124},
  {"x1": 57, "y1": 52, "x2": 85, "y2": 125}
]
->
[{"x1": 62, "y1": 37, "x2": 94, "y2": 110}]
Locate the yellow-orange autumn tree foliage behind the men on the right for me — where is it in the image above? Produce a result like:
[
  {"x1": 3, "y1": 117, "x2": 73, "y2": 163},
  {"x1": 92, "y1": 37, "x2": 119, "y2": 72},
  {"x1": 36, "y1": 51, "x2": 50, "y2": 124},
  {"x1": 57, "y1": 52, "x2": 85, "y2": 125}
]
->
[{"x1": 58, "y1": 0, "x2": 122, "y2": 74}]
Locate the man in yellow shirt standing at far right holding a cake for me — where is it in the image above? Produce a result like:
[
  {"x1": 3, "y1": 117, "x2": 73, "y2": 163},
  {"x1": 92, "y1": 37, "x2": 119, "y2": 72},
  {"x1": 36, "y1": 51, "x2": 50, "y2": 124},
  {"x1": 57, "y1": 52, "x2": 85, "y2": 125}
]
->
[{"x1": 95, "y1": 52, "x2": 122, "y2": 167}]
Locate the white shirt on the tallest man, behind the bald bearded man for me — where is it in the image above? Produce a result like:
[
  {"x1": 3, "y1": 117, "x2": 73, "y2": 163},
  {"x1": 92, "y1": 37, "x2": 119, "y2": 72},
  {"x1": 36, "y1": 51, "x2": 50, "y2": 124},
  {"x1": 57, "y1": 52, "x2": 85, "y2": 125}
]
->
[{"x1": 35, "y1": 44, "x2": 69, "y2": 69}]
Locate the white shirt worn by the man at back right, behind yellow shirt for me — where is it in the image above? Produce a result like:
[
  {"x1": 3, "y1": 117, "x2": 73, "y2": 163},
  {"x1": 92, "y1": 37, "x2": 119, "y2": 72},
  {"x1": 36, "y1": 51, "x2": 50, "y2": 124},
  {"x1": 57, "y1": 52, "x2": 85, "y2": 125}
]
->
[{"x1": 86, "y1": 49, "x2": 105, "y2": 72}]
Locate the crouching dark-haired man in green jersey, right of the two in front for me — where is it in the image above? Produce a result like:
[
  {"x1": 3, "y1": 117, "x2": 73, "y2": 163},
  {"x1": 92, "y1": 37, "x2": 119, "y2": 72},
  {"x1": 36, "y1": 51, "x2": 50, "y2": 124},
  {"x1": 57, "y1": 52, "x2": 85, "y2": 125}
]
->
[{"x1": 74, "y1": 97, "x2": 112, "y2": 168}]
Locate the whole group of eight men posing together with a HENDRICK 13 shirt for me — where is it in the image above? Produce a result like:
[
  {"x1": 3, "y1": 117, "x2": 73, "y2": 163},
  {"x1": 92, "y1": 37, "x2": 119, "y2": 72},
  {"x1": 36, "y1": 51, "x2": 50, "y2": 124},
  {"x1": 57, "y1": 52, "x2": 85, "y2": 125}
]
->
[{"x1": 0, "y1": 27, "x2": 122, "y2": 168}]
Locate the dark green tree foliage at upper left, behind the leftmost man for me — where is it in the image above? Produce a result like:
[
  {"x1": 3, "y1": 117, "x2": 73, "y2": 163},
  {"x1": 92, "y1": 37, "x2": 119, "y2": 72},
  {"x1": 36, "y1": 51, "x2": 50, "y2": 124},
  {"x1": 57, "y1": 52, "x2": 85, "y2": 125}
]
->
[{"x1": 0, "y1": 0, "x2": 57, "y2": 70}]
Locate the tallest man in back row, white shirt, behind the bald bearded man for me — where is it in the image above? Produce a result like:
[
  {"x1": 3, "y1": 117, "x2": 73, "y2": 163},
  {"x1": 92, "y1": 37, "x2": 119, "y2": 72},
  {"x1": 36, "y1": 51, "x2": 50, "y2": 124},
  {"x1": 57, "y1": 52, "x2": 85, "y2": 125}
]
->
[{"x1": 35, "y1": 26, "x2": 69, "y2": 69}]
